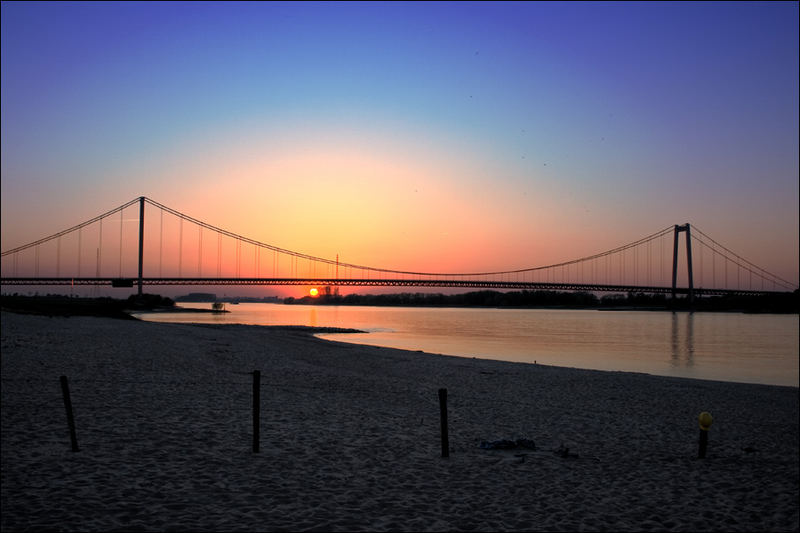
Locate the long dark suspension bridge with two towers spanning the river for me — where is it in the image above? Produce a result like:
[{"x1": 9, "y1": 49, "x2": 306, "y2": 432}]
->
[{"x1": 0, "y1": 196, "x2": 797, "y2": 302}]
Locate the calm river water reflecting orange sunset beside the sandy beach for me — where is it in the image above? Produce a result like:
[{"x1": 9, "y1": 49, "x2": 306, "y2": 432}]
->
[{"x1": 138, "y1": 303, "x2": 800, "y2": 387}]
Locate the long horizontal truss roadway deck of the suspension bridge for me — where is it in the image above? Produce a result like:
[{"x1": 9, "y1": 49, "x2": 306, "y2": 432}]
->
[{"x1": 0, "y1": 278, "x2": 786, "y2": 296}]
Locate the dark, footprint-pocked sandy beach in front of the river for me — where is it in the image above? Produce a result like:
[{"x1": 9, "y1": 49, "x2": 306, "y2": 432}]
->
[{"x1": 0, "y1": 312, "x2": 800, "y2": 531}]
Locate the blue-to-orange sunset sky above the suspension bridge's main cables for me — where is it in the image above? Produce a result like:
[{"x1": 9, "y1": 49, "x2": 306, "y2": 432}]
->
[{"x1": 1, "y1": 2, "x2": 800, "y2": 290}]
